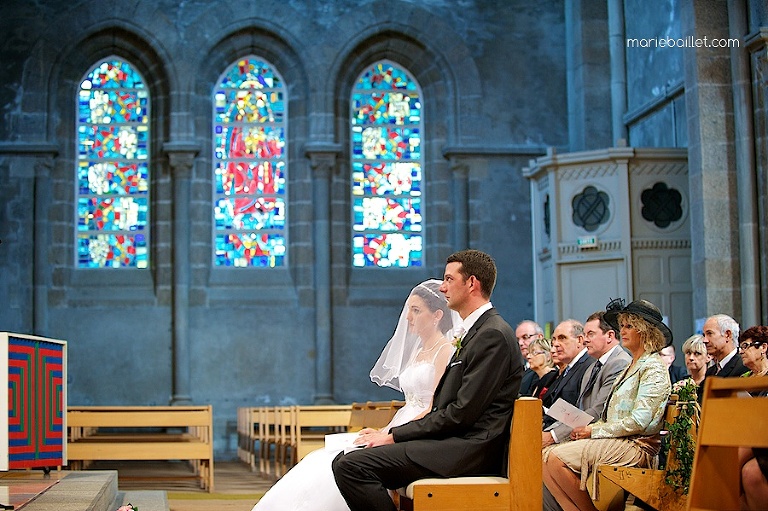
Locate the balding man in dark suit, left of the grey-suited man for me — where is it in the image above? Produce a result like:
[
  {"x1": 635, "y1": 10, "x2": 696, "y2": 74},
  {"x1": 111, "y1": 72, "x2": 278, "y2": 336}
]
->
[{"x1": 542, "y1": 319, "x2": 595, "y2": 429}]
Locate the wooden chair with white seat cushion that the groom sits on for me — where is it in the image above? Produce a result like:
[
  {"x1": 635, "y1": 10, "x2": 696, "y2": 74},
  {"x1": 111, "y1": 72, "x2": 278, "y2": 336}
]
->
[{"x1": 399, "y1": 397, "x2": 543, "y2": 511}]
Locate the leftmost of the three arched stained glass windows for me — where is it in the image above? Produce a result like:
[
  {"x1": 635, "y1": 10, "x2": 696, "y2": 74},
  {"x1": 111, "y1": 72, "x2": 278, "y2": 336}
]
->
[{"x1": 76, "y1": 58, "x2": 150, "y2": 268}]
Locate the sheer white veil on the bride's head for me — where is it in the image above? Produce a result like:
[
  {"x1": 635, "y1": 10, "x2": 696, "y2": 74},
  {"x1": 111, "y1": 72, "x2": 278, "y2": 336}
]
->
[{"x1": 371, "y1": 279, "x2": 461, "y2": 391}]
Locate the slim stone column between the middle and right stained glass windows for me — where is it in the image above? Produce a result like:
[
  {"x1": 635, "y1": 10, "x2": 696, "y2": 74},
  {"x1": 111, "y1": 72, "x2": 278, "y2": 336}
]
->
[{"x1": 306, "y1": 145, "x2": 340, "y2": 404}]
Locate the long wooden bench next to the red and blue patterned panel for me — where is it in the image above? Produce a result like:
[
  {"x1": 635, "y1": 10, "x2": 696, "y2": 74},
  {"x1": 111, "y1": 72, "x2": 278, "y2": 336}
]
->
[{"x1": 67, "y1": 405, "x2": 214, "y2": 492}]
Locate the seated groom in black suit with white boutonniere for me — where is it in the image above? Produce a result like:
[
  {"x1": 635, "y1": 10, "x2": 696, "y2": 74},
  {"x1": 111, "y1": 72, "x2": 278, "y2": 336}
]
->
[{"x1": 333, "y1": 250, "x2": 523, "y2": 511}]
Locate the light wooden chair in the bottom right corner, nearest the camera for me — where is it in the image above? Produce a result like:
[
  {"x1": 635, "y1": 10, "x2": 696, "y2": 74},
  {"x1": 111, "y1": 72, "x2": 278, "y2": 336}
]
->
[{"x1": 688, "y1": 376, "x2": 768, "y2": 511}]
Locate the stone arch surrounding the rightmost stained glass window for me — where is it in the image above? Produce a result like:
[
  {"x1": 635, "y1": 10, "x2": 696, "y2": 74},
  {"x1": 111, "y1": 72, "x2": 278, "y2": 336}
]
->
[{"x1": 326, "y1": 21, "x2": 480, "y2": 282}]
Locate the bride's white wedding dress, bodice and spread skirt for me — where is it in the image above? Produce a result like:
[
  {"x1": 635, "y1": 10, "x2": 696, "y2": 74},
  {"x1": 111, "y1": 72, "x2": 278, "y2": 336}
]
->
[{"x1": 251, "y1": 348, "x2": 442, "y2": 511}]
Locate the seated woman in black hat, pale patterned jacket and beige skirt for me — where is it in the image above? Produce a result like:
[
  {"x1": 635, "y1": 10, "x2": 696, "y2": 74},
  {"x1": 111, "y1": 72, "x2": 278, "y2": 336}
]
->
[{"x1": 543, "y1": 300, "x2": 672, "y2": 511}]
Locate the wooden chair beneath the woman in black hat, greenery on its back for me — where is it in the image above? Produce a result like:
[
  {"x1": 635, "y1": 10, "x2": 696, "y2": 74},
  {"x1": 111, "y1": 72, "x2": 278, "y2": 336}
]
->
[{"x1": 587, "y1": 402, "x2": 696, "y2": 511}]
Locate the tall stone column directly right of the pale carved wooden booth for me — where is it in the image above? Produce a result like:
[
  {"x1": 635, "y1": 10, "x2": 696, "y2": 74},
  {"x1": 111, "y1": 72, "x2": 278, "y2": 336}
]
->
[{"x1": 681, "y1": 2, "x2": 741, "y2": 319}]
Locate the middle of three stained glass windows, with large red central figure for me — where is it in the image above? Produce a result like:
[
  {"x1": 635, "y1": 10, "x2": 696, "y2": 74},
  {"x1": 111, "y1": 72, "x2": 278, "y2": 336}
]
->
[{"x1": 213, "y1": 56, "x2": 287, "y2": 268}]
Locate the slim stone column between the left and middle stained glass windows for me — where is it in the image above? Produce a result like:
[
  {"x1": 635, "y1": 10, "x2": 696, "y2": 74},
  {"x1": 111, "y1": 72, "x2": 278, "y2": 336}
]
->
[{"x1": 163, "y1": 143, "x2": 198, "y2": 405}]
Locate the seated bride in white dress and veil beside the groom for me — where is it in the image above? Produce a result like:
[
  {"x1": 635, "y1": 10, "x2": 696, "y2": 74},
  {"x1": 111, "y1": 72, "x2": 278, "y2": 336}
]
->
[{"x1": 251, "y1": 280, "x2": 461, "y2": 511}]
